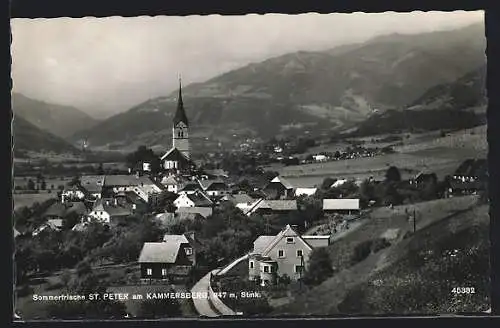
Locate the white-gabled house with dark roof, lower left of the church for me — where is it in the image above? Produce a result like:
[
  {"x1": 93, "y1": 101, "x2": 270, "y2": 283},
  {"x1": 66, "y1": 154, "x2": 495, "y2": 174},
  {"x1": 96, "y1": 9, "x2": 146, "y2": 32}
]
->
[{"x1": 88, "y1": 199, "x2": 136, "y2": 224}]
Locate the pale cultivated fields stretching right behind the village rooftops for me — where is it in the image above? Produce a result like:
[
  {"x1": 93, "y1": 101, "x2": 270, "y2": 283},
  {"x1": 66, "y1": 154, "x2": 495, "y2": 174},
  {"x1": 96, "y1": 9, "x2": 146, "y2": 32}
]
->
[{"x1": 272, "y1": 126, "x2": 487, "y2": 186}]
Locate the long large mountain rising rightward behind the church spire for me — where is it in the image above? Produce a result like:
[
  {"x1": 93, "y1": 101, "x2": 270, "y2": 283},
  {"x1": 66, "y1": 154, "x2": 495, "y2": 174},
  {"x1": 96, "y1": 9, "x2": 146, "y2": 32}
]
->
[{"x1": 73, "y1": 24, "x2": 486, "y2": 148}]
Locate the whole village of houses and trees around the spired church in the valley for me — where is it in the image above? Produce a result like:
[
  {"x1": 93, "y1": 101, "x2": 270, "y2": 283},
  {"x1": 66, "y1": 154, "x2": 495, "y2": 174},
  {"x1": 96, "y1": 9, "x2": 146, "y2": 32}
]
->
[{"x1": 14, "y1": 80, "x2": 486, "y2": 317}]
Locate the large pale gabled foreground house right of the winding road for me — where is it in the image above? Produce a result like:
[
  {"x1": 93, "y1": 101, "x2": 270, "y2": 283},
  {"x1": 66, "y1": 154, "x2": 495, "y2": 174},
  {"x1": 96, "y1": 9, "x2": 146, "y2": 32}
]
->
[{"x1": 248, "y1": 225, "x2": 330, "y2": 286}]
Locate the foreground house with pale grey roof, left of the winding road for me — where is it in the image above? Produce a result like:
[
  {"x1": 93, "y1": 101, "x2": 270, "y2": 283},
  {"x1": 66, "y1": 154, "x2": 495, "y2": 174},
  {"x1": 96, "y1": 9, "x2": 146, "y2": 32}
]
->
[{"x1": 138, "y1": 234, "x2": 197, "y2": 280}]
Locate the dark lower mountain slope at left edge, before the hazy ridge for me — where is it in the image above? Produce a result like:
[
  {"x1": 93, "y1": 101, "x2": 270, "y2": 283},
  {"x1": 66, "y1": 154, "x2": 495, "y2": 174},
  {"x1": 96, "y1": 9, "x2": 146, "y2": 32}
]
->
[{"x1": 12, "y1": 116, "x2": 79, "y2": 155}]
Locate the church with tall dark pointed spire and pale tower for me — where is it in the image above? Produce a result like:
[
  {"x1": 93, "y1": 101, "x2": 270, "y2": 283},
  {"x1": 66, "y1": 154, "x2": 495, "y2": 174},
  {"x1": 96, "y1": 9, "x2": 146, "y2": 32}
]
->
[{"x1": 161, "y1": 79, "x2": 193, "y2": 173}]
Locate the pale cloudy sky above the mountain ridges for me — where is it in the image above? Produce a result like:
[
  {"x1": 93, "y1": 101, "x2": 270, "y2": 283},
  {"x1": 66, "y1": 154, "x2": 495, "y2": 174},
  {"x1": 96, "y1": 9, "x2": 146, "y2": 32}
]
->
[{"x1": 11, "y1": 11, "x2": 484, "y2": 118}]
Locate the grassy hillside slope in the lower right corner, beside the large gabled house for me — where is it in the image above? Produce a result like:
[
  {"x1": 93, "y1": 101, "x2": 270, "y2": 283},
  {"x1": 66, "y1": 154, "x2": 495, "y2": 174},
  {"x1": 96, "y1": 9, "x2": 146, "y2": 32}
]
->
[{"x1": 273, "y1": 198, "x2": 490, "y2": 315}]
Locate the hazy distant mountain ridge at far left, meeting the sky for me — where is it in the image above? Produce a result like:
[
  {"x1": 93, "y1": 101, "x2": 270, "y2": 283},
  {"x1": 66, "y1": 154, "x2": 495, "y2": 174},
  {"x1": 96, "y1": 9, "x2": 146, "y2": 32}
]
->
[{"x1": 12, "y1": 93, "x2": 98, "y2": 138}]
